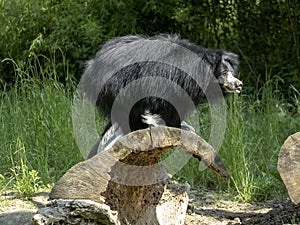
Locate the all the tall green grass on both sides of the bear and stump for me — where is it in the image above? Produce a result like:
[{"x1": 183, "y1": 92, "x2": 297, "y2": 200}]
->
[{"x1": 0, "y1": 61, "x2": 300, "y2": 201}]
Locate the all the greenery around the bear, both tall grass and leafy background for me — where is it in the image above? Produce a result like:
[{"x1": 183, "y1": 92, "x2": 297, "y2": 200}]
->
[{"x1": 0, "y1": 0, "x2": 300, "y2": 201}]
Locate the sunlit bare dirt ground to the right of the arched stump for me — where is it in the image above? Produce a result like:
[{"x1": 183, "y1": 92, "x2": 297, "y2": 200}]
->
[{"x1": 185, "y1": 192, "x2": 300, "y2": 225}]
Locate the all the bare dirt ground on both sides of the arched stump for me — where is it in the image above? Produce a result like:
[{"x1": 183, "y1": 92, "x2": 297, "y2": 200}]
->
[{"x1": 0, "y1": 191, "x2": 300, "y2": 225}]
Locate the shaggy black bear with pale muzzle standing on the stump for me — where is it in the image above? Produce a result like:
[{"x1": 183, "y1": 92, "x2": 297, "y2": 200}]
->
[{"x1": 82, "y1": 35, "x2": 242, "y2": 157}]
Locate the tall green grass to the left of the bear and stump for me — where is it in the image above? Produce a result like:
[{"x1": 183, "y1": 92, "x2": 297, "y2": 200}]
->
[{"x1": 0, "y1": 56, "x2": 82, "y2": 190}]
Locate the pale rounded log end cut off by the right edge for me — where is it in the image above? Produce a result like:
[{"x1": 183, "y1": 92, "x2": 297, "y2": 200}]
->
[{"x1": 277, "y1": 132, "x2": 300, "y2": 204}]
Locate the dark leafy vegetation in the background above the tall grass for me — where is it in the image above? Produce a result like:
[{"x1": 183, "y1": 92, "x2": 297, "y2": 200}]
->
[{"x1": 0, "y1": 0, "x2": 300, "y2": 94}]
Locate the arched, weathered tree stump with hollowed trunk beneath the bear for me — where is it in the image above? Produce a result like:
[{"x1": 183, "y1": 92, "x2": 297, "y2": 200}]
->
[{"x1": 33, "y1": 126, "x2": 229, "y2": 225}]
